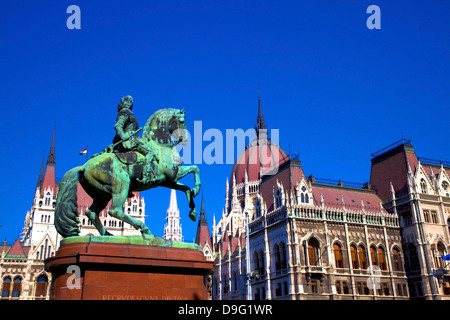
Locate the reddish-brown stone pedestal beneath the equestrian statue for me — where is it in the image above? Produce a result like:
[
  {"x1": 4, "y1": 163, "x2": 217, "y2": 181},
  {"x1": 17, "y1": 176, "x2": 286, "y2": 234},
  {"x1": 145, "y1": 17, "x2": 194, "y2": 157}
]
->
[{"x1": 45, "y1": 242, "x2": 213, "y2": 300}]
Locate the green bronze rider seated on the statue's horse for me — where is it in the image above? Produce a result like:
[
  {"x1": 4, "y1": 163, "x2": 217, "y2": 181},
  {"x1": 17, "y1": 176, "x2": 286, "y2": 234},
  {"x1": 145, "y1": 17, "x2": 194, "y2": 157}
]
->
[{"x1": 113, "y1": 96, "x2": 158, "y2": 184}]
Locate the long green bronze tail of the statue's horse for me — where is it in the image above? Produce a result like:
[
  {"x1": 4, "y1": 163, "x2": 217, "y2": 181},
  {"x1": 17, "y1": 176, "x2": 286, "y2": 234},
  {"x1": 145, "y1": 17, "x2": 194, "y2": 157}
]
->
[{"x1": 55, "y1": 166, "x2": 84, "y2": 237}]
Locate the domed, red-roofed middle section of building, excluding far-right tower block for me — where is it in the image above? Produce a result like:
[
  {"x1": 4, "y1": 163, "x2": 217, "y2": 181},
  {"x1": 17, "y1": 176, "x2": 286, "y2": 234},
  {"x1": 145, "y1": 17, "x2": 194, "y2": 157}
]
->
[{"x1": 212, "y1": 95, "x2": 410, "y2": 300}]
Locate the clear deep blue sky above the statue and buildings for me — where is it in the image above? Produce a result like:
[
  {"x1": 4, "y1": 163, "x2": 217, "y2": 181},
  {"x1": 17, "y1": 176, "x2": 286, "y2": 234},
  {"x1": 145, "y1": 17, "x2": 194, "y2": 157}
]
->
[{"x1": 0, "y1": 0, "x2": 450, "y2": 242}]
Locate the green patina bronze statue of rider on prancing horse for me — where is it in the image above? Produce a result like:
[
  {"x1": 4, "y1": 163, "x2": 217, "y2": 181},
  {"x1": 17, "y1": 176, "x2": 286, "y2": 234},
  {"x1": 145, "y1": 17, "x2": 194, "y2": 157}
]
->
[{"x1": 55, "y1": 96, "x2": 201, "y2": 239}]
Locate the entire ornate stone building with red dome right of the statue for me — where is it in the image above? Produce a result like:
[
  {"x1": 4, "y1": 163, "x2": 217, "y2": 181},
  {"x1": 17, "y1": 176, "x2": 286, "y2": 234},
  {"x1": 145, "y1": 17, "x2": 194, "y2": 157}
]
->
[{"x1": 212, "y1": 97, "x2": 450, "y2": 300}]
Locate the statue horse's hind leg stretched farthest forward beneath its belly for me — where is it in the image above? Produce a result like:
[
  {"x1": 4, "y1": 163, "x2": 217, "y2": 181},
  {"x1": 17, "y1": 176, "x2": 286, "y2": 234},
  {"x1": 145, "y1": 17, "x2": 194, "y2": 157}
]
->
[{"x1": 109, "y1": 170, "x2": 152, "y2": 237}]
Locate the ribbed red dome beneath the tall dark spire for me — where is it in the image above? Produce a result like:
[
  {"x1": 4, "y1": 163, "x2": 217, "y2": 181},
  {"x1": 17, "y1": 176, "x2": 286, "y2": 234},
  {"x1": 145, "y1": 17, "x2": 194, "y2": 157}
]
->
[{"x1": 230, "y1": 140, "x2": 289, "y2": 184}]
